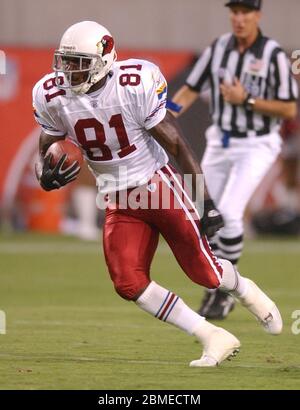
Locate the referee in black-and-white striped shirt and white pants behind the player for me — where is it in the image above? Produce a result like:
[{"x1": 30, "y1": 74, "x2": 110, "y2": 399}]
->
[{"x1": 170, "y1": 0, "x2": 298, "y2": 319}]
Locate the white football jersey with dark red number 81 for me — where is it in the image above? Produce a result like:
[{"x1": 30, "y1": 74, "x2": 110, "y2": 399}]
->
[{"x1": 33, "y1": 59, "x2": 168, "y2": 194}]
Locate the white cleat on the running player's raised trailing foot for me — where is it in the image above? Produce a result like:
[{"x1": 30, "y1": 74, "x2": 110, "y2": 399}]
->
[{"x1": 238, "y1": 278, "x2": 283, "y2": 335}]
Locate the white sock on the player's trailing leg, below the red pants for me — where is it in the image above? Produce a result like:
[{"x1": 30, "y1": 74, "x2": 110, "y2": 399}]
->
[{"x1": 219, "y1": 259, "x2": 248, "y2": 298}]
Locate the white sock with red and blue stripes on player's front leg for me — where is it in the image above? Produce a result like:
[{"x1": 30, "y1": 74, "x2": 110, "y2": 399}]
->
[{"x1": 135, "y1": 281, "x2": 206, "y2": 335}]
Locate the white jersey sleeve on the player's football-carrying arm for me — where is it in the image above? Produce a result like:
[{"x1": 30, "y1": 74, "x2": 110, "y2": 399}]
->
[{"x1": 32, "y1": 80, "x2": 66, "y2": 137}]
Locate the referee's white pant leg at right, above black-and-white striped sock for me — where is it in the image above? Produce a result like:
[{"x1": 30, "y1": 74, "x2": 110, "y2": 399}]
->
[{"x1": 218, "y1": 134, "x2": 280, "y2": 238}]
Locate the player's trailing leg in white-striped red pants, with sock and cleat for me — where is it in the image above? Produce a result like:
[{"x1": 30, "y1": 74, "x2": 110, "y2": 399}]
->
[{"x1": 156, "y1": 164, "x2": 282, "y2": 334}]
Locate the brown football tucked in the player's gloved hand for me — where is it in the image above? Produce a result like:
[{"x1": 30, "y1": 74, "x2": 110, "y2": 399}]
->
[{"x1": 46, "y1": 140, "x2": 83, "y2": 169}]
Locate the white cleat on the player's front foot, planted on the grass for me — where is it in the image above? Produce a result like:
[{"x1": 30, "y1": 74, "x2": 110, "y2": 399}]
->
[{"x1": 190, "y1": 327, "x2": 241, "y2": 367}]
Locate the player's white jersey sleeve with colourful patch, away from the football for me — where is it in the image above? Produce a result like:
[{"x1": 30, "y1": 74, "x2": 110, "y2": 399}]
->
[{"x1": 137, "y1": 62, "x2": 168, "y2": 130}]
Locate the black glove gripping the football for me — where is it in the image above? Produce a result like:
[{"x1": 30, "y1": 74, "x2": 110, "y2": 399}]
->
[{"x1": 35, "y1": 154, "x2": 80, "y2": 191}]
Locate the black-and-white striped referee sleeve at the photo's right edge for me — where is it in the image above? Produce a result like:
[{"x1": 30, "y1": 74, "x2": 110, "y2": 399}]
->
[{"x1": 272, "y1": 49, "x2": 299, "y2": 101}]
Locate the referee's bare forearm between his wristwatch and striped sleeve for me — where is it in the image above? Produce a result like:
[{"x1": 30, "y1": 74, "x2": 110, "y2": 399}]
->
[{"x1": 253, "y1": 99, "x2": 297, "y2": 119}]
